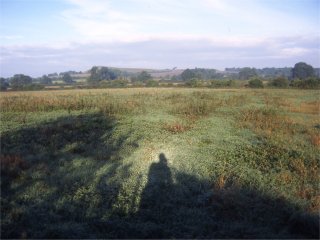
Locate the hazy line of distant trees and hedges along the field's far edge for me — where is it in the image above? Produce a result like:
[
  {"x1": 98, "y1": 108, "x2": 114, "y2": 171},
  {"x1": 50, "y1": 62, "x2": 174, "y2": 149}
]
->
[{"x1": 0, "y1": 62, "x2": 320, "y2": 91}]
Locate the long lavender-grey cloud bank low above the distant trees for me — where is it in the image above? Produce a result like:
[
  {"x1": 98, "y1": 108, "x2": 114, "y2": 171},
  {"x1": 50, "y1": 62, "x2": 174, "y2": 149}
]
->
[{"x1": 0, "y1": 36, "x2": 320, "y2": 76}]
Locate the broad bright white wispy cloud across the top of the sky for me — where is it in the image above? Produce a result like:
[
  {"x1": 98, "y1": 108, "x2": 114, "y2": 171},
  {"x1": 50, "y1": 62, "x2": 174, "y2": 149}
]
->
[{"x1": 61, "y1": 0, "x2": 317, "y2": 41}]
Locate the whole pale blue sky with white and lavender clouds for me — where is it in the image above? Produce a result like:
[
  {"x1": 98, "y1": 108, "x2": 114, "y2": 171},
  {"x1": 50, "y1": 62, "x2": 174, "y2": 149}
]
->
[{"x1": 0, "y1": 0, "x2": 320, "y2": 77}]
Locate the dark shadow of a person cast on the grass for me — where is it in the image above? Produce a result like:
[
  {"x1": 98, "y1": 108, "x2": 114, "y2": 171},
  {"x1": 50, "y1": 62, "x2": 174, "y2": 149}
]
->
[{"x1": 139, "y1": 153, "x2": 174, "y2": 238}]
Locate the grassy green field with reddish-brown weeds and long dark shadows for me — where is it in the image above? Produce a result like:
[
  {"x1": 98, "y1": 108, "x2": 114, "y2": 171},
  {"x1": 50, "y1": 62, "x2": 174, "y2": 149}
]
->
[{"x1": 0, "y1": 88, "x2": 320, "y2": 238}]
